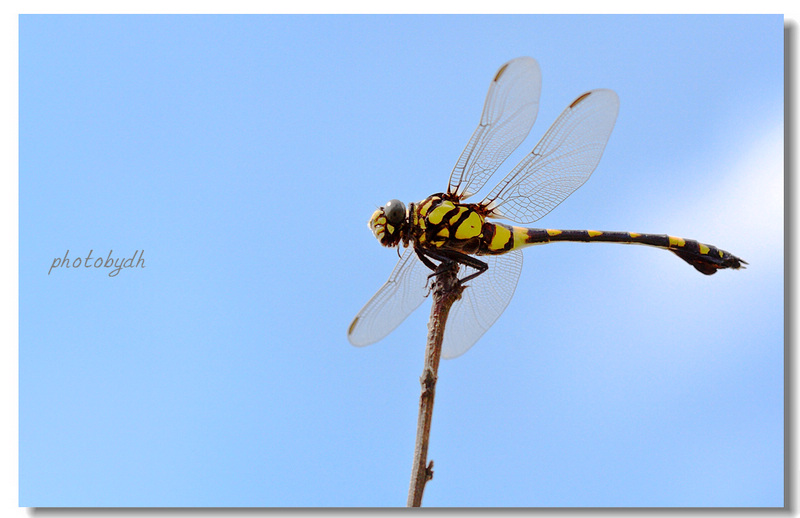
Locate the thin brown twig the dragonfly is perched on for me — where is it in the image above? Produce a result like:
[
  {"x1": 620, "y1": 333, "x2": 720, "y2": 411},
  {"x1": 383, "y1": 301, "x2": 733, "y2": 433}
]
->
[{"x1": 407, "y1": 263, "x2": 464, "y2": 507}]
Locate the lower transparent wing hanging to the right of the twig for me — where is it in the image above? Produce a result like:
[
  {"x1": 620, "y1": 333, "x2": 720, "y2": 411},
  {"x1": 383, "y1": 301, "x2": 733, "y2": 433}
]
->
[{"x1": 442, "y1": 250, "x2": 522, "y2": 359}]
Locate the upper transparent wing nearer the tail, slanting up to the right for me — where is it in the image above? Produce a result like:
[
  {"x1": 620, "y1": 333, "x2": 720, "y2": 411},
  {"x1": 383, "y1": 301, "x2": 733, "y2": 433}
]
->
[{"x1": 481, "y1": 90, "x2": 619, "y2": 224}]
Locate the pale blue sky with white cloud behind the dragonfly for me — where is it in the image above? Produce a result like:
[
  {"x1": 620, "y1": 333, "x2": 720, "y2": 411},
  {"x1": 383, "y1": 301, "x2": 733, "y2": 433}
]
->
[{"x1": 19, "y1": 15, "x2": 784, "y2": 507}]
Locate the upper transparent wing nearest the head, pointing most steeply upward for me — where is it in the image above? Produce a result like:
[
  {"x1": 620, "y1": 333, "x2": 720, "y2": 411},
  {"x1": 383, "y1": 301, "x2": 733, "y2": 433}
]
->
[{"x1": 447, "y1": 57, "x2": 542, "y2": 199}]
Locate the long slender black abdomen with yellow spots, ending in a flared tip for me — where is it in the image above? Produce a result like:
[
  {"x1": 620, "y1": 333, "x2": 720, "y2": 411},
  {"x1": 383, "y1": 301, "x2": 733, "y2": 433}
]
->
[{"x1": 479, "y1": 223, "x2": 747, "y2": 275}]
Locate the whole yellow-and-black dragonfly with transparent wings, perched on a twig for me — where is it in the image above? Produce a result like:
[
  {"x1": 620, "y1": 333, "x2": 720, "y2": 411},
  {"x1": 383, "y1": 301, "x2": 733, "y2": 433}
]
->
[{"x1": 347, "y1": 57, "x2": 747, "y2": 358}]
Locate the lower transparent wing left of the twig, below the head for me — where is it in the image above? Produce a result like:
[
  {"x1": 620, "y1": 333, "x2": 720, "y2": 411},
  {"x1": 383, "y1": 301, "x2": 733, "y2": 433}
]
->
[{"x1": 347, "y1": 247, "x2": 431, "y2": 347}]
